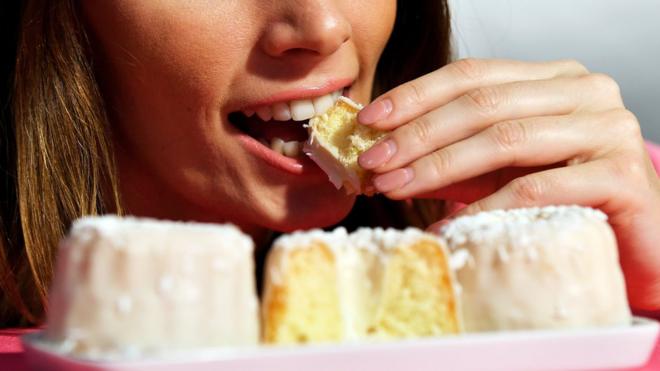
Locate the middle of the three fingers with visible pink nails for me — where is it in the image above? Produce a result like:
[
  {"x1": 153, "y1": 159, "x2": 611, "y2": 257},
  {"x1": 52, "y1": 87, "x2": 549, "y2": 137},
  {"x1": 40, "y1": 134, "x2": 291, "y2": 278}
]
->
[{"x1": 359, "y1": 75, "x2": 622, "y2": 173}]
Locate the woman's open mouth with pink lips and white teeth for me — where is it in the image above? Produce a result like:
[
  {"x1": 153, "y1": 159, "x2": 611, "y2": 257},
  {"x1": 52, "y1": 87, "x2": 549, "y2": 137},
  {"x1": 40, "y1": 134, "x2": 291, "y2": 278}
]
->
[{"x1": 229, "y1": 82, "x2": 348, "y2": 175}]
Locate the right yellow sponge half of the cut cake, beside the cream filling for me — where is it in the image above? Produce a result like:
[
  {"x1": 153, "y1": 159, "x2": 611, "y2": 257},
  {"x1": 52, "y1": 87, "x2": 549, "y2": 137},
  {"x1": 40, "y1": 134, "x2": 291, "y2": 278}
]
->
[{"x1": 351, "y1": 228, "x2": 462, "y2": 338}]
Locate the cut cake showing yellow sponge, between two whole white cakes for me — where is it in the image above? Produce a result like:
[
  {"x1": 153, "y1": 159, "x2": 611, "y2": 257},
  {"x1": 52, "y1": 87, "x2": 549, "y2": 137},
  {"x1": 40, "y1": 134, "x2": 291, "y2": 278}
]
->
[{"x1": 262, "y1": 228, "x2": 461, "y2": 344}]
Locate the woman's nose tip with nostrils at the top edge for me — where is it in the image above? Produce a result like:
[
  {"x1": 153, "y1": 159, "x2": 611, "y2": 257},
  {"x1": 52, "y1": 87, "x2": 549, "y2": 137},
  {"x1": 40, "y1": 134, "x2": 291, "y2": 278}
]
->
[{"x1": 260, "y1": 0, "x2": 351, "y2": 57}]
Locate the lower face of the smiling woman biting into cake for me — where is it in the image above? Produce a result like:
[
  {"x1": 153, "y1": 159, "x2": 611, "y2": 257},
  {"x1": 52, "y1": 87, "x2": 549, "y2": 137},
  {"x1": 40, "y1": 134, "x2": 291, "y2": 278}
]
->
[{"x1": 80, "y1": 0, "x2": 396, "y2": 232}]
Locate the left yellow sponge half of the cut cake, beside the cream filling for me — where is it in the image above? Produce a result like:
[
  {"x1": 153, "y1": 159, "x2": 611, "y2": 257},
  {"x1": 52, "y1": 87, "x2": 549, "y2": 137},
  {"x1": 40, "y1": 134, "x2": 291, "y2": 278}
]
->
[{"x1": 261, "y1": 228, "x2": 347, "y2": 344}]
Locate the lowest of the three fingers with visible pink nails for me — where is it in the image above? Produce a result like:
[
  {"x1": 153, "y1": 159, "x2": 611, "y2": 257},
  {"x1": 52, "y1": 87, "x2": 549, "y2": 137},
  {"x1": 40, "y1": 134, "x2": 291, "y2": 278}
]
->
[{"x1": 373, "y1": 110, "x2": 627, "y2": 199}]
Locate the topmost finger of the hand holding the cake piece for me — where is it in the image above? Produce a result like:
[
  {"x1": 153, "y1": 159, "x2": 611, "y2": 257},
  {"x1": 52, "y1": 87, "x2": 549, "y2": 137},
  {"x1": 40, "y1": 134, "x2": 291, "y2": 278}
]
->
[{"x1": 358, "y1": 59, "x2": 588, "y2": 130}]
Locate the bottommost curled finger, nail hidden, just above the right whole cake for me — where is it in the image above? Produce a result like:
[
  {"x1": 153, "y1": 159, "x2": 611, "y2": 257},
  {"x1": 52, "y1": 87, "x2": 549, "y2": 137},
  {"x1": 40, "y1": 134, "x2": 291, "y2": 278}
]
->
[{"x1": 456, "y1": 161, "x2": 625, "y2": 216}]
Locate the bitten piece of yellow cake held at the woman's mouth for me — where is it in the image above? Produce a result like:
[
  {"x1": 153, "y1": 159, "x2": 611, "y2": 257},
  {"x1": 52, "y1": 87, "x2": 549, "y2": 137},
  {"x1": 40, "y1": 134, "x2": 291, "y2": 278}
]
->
[{"x1": 303, "y1": 97, "x2": 386, "y2": 195}]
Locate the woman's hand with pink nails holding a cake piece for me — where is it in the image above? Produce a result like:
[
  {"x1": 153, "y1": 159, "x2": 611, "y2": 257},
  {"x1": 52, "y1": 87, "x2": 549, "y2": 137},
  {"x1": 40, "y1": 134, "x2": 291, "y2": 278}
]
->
[{"x1": 358, "y1": 59, "x2": 660, "y2": 310}]
